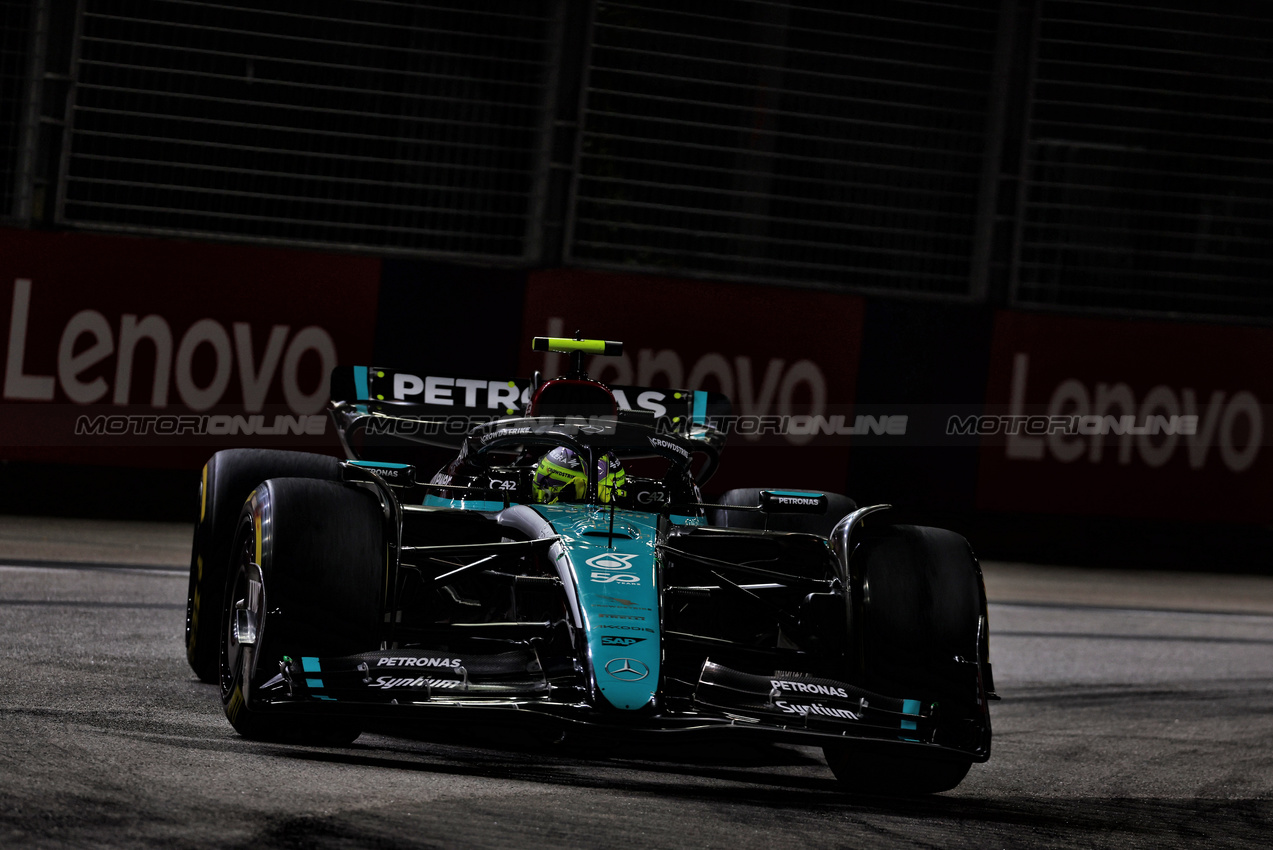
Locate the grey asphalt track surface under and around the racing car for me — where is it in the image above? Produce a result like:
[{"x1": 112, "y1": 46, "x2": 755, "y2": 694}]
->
[{"x1": 0, "y1": 518, "x2": 1273, "y2": 850}]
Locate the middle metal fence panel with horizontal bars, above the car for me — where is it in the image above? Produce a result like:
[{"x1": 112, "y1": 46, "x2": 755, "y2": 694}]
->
[{"x1": 568, "y1": 0, "x2": 999, "y2": 295}]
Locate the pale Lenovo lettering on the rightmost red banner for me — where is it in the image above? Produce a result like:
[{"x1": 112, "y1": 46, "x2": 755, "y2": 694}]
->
[{"x1": 1004, "y1": 351, "x2": 1264, "y2": 472}]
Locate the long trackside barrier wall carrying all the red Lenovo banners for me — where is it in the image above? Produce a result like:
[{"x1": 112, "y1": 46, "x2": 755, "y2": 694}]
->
[{"x1": 0, "y1": 230, "x2": 1273, "y2": 567}]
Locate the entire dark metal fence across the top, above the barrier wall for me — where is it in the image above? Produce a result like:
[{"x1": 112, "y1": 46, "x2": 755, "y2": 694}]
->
[{"x1": 0, "y1": 0, "x2": 1273, "y2": 321}]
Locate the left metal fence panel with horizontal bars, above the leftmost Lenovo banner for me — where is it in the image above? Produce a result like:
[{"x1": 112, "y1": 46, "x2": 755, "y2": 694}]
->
[{"x1": 59, "y1": 0, "x2": 550, "y2": 260}]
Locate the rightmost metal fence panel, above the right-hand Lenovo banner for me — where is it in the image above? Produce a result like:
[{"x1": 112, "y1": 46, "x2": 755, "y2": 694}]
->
[{"x1": 1015, "y1": 0, "x2": 1273, "y2": 318}]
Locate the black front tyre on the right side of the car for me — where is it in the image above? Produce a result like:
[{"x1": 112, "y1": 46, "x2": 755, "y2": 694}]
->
[{"x1": 825, "y1": 526, "x2": 989, "y2": 794}]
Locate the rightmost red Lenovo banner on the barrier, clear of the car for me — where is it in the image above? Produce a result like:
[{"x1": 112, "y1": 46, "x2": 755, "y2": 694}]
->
[{"x1": 977, "y1": 312, "x2": 1273, "y2": 523}]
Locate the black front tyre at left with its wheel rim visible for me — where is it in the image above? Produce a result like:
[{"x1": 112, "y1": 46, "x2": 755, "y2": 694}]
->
[{"x1": 219, "y1": 478, "x2": 384, "y2": 743}]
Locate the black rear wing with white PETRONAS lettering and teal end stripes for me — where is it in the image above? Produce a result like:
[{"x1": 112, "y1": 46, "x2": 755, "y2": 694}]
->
[{"x1": 331, "y1": 366, "x2": 732, "y2": 447}]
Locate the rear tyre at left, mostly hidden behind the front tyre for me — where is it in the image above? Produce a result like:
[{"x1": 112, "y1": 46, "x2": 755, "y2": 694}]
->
[{"x1": 186, "y1": 449, "x2": 340, "y2": 683}]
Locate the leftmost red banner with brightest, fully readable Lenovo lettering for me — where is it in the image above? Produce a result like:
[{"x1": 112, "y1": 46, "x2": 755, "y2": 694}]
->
[{"x1": 0, "y1": 229, "x2": 379, "y2": 468}]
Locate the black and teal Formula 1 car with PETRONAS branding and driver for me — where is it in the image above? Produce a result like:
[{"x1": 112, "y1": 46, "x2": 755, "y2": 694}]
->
[{"x1": 186, "y1": 337, "x2": 997, "y2": 794}]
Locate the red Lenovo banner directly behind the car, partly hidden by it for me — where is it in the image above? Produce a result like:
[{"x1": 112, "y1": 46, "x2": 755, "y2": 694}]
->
[{"x1": 519, "y1": 270, "x2": 863, "y2": 492}]
